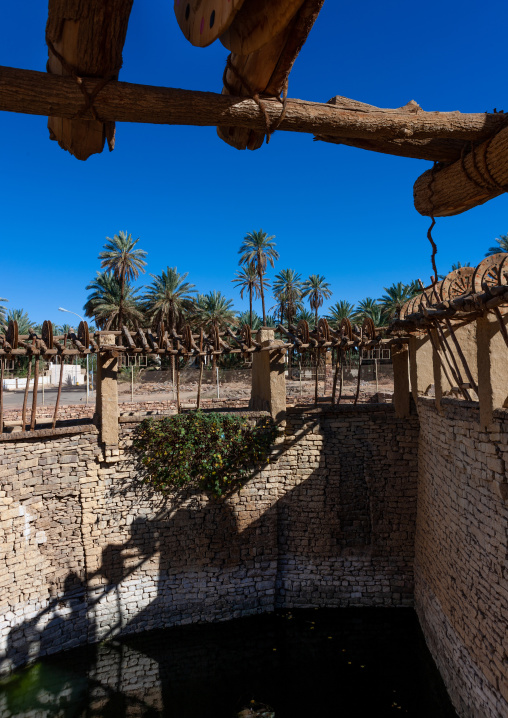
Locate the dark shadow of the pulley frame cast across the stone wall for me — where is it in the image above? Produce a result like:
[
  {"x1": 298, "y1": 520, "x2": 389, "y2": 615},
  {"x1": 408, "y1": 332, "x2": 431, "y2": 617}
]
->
[{"x1": 4, "y1": 419, "x2": 418, "y2": 667}]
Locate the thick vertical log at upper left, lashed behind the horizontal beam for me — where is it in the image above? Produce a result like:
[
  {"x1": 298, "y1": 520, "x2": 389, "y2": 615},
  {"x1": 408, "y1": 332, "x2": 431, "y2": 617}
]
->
[{"x1": 46, "y1": 0, "x2": 133, "y2": 160}]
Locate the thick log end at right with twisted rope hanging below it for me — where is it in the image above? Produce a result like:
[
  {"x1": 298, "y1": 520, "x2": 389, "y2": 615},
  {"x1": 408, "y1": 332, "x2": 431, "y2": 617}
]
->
[{"x1": 413, "y1": 121, "x2": 508, "y2": 217}]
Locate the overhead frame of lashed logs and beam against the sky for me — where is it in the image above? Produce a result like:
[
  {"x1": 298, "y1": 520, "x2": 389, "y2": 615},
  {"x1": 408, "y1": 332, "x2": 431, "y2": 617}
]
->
[{"x1": 0, "y1": 0, "x2": 508, "y2": 217}]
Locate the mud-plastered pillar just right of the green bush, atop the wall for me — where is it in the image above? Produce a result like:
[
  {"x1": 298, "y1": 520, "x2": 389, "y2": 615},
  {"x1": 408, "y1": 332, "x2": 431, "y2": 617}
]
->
[{"x1": 249, "y1": 327, "x2": 286, "y2": 423}]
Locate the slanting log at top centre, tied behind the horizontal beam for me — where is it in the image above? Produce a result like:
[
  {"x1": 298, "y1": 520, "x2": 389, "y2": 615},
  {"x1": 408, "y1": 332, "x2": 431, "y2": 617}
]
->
[{"x1": 217, "y1": 0, "x2": 324, "y2": 150}]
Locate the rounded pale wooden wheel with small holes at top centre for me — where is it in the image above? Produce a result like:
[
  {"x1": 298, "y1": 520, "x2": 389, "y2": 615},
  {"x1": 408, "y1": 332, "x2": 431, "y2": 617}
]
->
[{"x1": 174, "y1": 0, "x2": 244, "y2": 47}]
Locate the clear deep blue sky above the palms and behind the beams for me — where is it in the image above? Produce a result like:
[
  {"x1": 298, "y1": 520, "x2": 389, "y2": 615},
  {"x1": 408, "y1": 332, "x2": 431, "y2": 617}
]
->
[{"x1": 0, "y1": 0, "x2": 508, "y2": 323}]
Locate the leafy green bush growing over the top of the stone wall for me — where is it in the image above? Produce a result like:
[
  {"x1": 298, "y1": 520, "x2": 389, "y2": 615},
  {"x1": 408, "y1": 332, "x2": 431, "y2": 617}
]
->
[{"x1": 133, "y1": 411, "x2": 278, "y2": 497}]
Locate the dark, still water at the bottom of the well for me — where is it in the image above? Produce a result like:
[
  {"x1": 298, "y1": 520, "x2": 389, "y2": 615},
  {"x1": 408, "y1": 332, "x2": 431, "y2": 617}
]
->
[{"x1": 0, "y1": 608, "x2": 456, "y2": 718}]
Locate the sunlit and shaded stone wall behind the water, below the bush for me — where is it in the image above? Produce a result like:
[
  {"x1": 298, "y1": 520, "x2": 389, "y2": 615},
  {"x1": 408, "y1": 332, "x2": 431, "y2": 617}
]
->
[{"x1": 0, "y1": 405, "x2": 418, "y2": 671}]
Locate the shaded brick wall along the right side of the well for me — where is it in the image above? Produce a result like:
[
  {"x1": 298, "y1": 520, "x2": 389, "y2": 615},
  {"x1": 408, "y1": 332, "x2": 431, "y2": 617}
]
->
[{"x1": 415, "y1": 399, "x2": 508, "y2": 718}]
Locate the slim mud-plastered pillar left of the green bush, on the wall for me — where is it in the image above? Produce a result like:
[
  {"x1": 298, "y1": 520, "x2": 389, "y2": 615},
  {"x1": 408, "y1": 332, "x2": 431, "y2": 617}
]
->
[{"x1": 96, "y1": 348, "x2": 118, "y2": 447}]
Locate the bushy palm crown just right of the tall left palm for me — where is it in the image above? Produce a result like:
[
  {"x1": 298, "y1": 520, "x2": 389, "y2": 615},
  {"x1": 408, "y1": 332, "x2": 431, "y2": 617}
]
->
[{"x1": 143, "y1": 267, "x2": 196, "y2": 331}]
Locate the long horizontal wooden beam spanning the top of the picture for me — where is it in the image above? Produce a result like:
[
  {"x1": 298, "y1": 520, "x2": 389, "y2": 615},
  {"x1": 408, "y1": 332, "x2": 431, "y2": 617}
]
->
[{"x1": 0, "y1": 67, "x2": 504, "y2": 159}]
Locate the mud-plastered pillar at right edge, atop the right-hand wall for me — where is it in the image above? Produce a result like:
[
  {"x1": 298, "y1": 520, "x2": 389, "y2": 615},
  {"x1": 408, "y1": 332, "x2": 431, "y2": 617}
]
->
[{"x1": 476, "y1": 314, "x2": 508, "y2": 429}]
